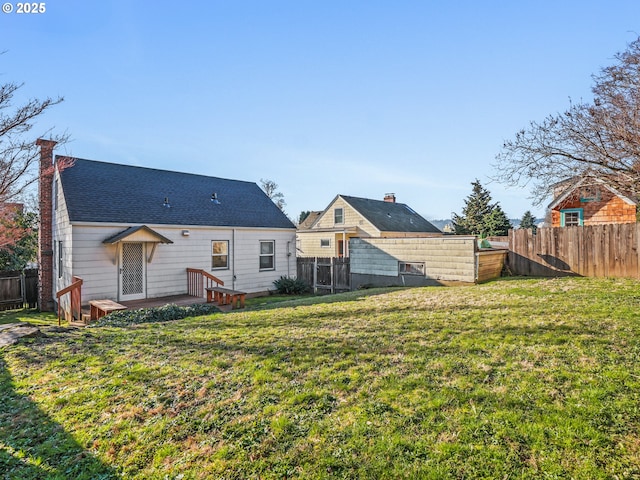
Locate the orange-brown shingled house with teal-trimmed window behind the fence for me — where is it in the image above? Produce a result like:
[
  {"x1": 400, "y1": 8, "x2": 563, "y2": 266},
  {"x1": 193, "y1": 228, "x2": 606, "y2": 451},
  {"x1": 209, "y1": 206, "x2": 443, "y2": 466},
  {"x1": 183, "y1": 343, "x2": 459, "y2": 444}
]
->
[{"x1": 549, "y1": 175, "x2": 638, "y2": 227}]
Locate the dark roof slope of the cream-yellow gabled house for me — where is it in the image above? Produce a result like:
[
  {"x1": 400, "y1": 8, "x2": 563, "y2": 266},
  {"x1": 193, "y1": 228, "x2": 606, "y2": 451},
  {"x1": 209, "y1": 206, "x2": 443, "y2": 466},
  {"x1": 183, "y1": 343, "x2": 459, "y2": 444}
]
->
[{"x1": 340, "y1": 195, "x2": 442, "y2": 233}]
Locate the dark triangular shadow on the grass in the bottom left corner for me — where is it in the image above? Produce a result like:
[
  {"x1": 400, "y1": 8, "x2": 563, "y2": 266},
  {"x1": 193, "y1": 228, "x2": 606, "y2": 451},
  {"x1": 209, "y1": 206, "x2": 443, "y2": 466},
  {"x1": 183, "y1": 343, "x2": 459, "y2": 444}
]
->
[{"x1": 0, "y1": 354, "x2": 119, "y2": 479}]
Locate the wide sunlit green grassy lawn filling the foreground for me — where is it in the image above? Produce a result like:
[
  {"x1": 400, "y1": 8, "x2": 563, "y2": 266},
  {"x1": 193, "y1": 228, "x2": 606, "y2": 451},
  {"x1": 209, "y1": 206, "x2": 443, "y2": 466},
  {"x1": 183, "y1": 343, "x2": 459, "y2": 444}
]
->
[{"x1": 0, "y1": 278, "x2": 640, "y2": 479}]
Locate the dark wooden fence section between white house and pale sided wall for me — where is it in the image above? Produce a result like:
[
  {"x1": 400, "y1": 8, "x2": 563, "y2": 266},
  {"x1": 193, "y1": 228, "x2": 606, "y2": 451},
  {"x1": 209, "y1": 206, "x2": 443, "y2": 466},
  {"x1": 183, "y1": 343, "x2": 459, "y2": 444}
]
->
[{"x1": 296, "y1": 257, "x2": 351, "y2": 293}]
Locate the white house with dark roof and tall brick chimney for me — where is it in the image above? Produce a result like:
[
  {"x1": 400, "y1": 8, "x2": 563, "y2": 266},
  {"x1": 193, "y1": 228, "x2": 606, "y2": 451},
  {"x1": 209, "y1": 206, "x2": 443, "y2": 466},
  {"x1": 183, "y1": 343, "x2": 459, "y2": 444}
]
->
[{"x1": 39, "y1": 140, "x2": 296, "y2": 309}]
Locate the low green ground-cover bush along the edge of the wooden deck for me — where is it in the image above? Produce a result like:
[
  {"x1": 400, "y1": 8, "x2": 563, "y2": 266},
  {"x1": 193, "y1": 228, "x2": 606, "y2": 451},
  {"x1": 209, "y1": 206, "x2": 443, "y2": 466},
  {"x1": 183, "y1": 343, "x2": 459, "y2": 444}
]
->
[{"x1": 91, "y1": 303, "x2": 220, "y2": 327}]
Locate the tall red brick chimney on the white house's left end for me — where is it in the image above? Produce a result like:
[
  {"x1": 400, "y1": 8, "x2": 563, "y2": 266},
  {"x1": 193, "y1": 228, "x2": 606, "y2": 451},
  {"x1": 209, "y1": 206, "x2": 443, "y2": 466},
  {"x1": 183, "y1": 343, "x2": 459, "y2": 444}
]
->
[{"x1": 36, "y1": 138, "x2": 57, "y2": 312}]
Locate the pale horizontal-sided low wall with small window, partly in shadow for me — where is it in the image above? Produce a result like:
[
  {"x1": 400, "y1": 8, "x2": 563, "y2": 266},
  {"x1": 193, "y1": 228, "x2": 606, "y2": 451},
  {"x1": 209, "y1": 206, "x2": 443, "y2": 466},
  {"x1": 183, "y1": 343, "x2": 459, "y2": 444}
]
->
[{"x1": 349, "y1": 236, "x2": 476, "y2": 282}]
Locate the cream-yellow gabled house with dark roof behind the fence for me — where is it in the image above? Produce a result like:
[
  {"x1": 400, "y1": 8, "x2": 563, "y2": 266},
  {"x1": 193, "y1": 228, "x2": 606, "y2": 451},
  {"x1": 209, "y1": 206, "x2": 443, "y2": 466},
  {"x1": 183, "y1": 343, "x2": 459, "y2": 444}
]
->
[{"x1": 296, "y1": 194, "x2": 442, "y2": 257}]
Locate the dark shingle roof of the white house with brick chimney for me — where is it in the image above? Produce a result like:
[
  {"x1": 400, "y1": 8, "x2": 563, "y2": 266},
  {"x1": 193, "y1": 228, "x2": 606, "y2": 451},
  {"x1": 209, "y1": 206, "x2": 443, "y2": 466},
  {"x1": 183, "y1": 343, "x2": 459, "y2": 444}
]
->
[{"x1": 60, "y1": 159, "x2": 295, "y2": 228}]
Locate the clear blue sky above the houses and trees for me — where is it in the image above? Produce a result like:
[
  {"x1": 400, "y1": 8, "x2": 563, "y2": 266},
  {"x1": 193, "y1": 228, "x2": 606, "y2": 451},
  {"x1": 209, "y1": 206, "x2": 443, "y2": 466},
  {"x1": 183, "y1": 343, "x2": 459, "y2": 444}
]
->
[{"x1": 0, "y1": 0, "x2": 640, "y2": 219}]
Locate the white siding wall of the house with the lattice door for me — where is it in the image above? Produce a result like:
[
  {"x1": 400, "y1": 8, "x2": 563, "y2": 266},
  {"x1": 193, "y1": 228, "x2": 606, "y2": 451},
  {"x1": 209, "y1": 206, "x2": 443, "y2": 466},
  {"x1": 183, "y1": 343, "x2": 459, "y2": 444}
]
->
[{"x1": 66, "y1": 224, "x2": 295, "y2": 303}]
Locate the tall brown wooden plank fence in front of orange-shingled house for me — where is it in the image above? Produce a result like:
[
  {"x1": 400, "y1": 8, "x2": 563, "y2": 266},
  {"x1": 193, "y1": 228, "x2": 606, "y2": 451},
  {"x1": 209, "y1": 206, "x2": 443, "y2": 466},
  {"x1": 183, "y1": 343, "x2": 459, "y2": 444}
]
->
[{"x1": 507, "y1": 223, "x2": 640, "y2": 278}]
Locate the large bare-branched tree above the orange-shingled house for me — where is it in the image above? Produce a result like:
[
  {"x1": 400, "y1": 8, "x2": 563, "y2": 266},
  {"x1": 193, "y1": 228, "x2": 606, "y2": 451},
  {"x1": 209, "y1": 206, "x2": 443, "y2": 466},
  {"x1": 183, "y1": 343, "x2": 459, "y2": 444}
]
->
[{"x1": 494, "y1": 38, "x2": 640, "y2": 204}]
